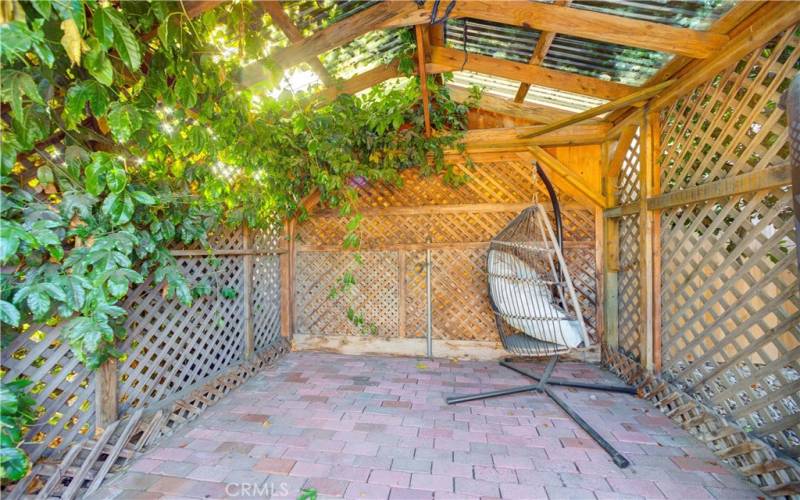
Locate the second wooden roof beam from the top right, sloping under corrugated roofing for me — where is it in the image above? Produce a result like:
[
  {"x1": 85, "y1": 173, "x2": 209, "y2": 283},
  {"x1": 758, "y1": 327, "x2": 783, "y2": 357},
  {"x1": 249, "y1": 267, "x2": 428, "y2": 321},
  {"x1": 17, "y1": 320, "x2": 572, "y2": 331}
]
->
[{"x1": 431, "y1": 47, "x2": 637, "y2": 100}]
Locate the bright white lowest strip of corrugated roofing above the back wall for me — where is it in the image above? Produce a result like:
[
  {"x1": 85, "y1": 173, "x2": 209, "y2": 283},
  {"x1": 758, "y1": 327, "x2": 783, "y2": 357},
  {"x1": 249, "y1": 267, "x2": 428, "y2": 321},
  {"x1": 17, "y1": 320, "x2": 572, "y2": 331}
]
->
[{"x1": 451, "y1": 71, "x2": 607, "y2": 113}]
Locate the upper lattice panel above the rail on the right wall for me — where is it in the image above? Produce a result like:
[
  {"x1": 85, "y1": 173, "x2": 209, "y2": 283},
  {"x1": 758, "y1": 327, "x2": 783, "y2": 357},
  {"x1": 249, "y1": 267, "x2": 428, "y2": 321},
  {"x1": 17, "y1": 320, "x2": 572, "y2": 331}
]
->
[{"x1": 660, "y1": 28, "x2": 800, "y2": 192}]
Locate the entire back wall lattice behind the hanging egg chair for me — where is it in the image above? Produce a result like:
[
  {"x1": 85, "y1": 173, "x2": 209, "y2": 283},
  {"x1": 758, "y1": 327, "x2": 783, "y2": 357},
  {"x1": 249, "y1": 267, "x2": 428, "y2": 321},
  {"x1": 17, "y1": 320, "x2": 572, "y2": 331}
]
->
[{"x1": 295, "y1": 160, "x2": 597, "y2": 340}]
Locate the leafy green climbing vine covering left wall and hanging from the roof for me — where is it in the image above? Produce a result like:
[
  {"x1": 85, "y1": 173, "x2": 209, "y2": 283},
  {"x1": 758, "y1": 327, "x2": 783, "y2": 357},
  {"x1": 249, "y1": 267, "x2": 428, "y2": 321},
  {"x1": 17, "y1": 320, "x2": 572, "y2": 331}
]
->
[{"x1": 0, "y1": 0, "x2": 476, "y2": 479}]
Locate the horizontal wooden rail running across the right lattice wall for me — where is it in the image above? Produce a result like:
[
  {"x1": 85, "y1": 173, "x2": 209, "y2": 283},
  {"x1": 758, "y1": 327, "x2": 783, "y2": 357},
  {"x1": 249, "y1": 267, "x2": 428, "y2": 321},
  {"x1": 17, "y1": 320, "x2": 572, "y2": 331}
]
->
[{"x1": 603, "y1": 164, "x2": 792, "y2": 218}]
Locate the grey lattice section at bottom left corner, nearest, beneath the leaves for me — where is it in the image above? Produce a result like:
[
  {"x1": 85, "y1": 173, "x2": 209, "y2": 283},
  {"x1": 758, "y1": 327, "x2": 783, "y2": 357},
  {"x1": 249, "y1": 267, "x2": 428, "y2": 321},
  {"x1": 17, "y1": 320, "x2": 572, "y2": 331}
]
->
[{"x1": 2, "y1": 324, "x2": 94, "y2": 461}]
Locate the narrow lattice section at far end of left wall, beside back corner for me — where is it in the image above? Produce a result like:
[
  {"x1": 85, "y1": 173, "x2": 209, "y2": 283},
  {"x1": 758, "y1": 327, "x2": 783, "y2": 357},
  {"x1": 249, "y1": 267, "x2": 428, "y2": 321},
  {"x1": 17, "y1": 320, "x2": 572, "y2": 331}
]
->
[{"x1": 251, "y1": 222, "x2": 282, "y2": 352}]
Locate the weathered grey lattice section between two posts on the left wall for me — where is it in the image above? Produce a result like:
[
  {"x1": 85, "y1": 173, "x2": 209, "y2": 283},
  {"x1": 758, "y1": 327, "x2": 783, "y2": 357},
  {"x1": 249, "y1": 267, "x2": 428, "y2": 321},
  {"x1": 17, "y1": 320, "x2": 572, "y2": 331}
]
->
[{"x1": 119, "y1": 231, "x2": 244, "y2": 410}]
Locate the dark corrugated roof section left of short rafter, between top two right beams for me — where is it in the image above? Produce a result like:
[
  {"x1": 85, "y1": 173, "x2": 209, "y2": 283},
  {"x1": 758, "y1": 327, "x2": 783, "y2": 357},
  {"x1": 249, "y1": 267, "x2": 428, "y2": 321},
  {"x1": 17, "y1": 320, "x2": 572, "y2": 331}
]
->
[{"x1": 445, "y1": 19, "x2": 539, "y2": 62}]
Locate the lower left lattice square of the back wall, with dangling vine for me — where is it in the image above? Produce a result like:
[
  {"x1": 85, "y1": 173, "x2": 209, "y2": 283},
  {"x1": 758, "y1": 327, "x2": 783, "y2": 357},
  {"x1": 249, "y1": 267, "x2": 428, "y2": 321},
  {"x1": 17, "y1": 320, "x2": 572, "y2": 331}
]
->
[{"x1": 295, "y1": 251, "x2": 399, "y2": 337}]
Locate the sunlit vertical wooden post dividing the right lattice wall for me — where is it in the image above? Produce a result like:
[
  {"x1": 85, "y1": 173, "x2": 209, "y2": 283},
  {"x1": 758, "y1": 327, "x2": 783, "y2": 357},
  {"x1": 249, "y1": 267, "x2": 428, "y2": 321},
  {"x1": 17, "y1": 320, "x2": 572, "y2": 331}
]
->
[{"x1": 639, "y1": 107, "x2": 655, "y2": 370}]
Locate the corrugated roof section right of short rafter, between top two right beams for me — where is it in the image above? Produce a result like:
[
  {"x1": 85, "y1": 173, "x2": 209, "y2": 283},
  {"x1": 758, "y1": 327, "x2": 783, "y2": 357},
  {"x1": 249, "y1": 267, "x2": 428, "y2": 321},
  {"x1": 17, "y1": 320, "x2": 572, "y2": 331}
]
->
[{"x1": 542, "y1": 34, "x2": 672, "y2": 85}]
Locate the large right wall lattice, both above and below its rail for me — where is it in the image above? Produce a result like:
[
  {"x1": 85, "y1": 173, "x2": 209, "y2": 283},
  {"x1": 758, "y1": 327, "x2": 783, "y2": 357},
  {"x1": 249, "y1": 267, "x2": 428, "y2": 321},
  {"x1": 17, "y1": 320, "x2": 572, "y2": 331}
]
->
[{"x1": 661, "y1": 25, "x2": 800, "y2": 457}]
